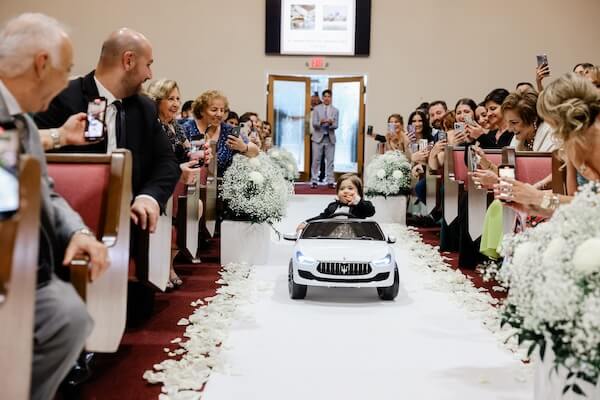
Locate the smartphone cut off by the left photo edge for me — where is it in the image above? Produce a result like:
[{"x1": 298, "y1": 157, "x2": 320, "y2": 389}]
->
[{"x1": 0, "y1": 121, "x2": 19, "y2": 220}]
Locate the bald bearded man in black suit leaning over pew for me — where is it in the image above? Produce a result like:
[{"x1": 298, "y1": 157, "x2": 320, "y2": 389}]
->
[{"x1": 35, "y1": 28, "x2": 180, "y2": 232}]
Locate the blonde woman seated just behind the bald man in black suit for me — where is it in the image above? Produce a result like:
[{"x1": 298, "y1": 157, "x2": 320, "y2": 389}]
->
[{"x1": 146, "y1": 79, "x2": 210, "y2": 289}]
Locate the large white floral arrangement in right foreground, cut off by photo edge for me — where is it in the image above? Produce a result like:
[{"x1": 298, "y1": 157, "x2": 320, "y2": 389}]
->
[{"x1": 498, "y1": 183, "x2": 600, "y2": 394}]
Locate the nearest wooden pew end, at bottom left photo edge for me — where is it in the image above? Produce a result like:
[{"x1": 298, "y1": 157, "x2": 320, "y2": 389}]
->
[{"x1": 0, "y1": 156, "x2": 41, "y2": 400}]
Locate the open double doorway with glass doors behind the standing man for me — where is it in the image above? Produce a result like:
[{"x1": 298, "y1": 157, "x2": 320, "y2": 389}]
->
[{"x1": 267, "y1": 75, "x2": 366, "y2": 181}]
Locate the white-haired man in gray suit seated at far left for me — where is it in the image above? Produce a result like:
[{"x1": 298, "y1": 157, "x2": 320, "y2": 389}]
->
[{"x1": 0, "y1": 14, "x2": 109, "y2": 400}]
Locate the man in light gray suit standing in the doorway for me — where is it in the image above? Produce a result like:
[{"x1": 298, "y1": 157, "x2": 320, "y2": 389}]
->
[{"x1": 310, "y1": 89, "x2": 339, "y2": 188}]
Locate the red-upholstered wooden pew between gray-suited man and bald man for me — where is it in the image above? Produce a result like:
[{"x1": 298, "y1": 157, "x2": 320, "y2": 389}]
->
[{"x1": 47, "y1": 149, "x2": 131, "y2": 352}]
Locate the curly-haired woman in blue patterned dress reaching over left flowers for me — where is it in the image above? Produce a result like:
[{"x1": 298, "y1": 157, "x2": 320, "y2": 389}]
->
[{"x1": 183, "y1": 90, "x2": 259, "y2": 177}]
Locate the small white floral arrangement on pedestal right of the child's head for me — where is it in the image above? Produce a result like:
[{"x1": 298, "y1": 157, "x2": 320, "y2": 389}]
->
[{"x1": 365, "y1": 151, "x2": 411, "y2": 197}]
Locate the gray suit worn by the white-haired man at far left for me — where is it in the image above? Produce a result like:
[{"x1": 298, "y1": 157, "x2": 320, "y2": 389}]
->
[{"x1": 0, "y1": 85, "x2": 92, "y2": 400}]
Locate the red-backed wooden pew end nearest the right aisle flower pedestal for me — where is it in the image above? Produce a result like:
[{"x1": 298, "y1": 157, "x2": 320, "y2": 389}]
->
[{"x1": 444, "y1": 145, "x2": 467, "y2": 225}]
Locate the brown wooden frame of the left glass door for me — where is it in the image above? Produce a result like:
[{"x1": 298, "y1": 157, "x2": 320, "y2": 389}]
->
[{"x1": 267, "y1": 74, "x2": 311, "y2": 181}]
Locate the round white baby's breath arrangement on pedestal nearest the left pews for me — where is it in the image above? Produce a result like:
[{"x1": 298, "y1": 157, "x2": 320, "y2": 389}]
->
[{"x1": 221, "y1": 154, "x2": 292, "y2": 223}]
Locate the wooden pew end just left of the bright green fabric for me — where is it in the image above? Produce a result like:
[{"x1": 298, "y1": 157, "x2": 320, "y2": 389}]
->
[{"x1": 467, "y1": 149, "x2": 508, "y2": 240}]
